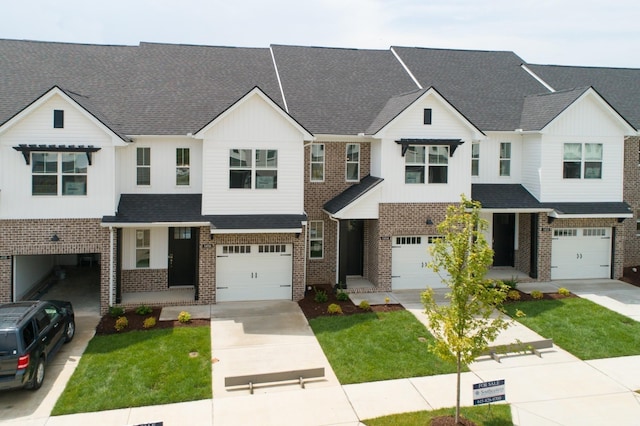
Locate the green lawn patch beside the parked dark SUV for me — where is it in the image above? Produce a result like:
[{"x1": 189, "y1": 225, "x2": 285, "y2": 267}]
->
[{"x1": 52, "y1": 326, "x2": 212, "y2": 416}]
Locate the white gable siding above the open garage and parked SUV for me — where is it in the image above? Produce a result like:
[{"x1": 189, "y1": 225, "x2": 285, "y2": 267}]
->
[{"x1": 0, "y1": 95, "x2": 116, "y2": 219}]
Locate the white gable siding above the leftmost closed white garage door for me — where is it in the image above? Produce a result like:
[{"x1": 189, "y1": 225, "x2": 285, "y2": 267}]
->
[{"x1": 202, "y1": 95, "x2": 304, "y2": 214}]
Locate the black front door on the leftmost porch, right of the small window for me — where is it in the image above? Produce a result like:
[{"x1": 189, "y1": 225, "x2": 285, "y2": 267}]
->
[{"x1": 168, "y1": 227, "x2": 197, "y2": 287}]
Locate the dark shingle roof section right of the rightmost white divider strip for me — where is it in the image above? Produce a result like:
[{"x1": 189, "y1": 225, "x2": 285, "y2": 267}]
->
[{"x1": 527, "y1": 64, "x2": 640, "y2": 129}]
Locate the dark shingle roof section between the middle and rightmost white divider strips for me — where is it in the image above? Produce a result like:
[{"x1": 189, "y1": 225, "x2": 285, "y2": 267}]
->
[{"x1": 392, "y1": 47, "x2": 552, "y2": 131}]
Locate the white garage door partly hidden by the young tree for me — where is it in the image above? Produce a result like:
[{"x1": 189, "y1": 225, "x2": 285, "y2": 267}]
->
[{"x1": 391, "y1": 235, "x2": 446, "y2": 290}]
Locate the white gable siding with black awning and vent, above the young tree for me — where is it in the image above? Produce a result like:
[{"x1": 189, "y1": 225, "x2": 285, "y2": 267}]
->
[{"x1": 371, "y1": 95, "x2": 473, "y2": 203}]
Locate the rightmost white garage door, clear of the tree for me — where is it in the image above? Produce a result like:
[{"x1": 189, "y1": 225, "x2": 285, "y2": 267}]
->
[{"x1": 551, "y1": 228, "x2": 611, "y2": 280}]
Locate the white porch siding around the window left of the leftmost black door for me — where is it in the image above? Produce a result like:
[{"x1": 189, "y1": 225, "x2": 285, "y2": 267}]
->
[{"x1": 122, "y1": 226, "x2": 169, "y2": 269}]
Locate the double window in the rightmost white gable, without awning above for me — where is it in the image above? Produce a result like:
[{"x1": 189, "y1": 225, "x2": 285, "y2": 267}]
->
[{"x1": 562, "y1": 143, "x2": 602, "y2": 179}]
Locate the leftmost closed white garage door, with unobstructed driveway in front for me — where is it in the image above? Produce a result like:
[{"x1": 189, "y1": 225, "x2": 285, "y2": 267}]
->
[{"x1": 216, "y1": 244, "x2": 293, "y2": 302}]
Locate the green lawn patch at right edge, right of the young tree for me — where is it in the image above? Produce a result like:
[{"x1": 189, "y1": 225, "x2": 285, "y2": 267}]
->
[{"x1": 504, "y1": 298, "x2": 640, "y2": 360}]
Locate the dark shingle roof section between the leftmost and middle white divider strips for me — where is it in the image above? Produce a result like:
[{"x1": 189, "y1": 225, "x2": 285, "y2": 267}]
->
[{"x1": 271, "y1": 45, "x2": 418, "y2": 135}]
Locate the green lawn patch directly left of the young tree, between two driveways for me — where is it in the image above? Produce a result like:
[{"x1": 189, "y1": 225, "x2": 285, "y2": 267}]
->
[{"x1": 309, "y1": 311, "x2": 468, "y2": 384}]
